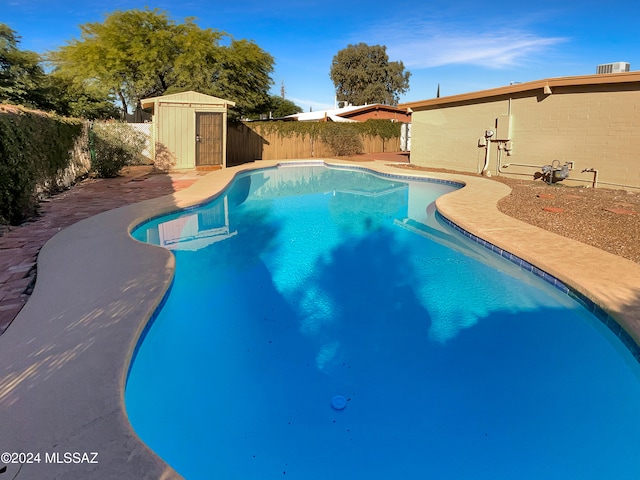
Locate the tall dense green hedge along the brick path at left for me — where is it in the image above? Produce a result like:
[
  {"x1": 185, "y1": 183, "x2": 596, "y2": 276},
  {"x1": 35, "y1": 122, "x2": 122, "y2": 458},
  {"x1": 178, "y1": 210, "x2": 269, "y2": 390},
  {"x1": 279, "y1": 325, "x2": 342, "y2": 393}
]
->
[{"x1": 0, "y1": 105, "x2": 83, "y2": 224}]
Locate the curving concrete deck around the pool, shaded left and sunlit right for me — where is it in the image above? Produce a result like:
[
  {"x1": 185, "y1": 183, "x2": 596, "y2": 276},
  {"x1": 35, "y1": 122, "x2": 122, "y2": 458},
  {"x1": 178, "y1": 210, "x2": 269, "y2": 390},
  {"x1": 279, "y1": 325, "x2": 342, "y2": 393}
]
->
[{"x1": 0, "y1": 160, "x2": 640, "y2": 479}]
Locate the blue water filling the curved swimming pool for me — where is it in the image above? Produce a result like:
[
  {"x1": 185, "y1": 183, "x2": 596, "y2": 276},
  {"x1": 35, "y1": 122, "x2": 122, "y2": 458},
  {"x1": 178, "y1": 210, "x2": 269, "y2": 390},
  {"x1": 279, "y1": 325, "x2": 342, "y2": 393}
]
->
[{"x1": 125, "y1": 166, "x2": 640, "y2": 480}]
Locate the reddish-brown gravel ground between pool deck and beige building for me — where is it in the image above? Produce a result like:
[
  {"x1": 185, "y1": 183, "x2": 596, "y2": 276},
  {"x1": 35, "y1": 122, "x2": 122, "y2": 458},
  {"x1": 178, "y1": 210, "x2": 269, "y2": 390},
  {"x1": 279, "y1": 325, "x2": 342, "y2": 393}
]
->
[{"x1": 392, "y1": 164, "x2": 640, "y2": 263}]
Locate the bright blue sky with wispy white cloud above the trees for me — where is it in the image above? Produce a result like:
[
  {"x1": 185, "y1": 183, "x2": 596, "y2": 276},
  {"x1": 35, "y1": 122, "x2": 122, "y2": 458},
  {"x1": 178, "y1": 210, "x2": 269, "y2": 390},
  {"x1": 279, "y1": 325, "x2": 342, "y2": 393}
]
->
[{"x1": 0, "y1": 0, "x2": 640, "y2": 111}]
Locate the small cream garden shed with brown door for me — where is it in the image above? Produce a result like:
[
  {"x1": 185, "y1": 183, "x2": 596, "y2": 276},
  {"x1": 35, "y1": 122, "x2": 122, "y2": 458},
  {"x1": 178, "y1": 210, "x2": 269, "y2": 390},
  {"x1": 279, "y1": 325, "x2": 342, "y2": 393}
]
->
[{"x1": 141, "y1": 91, "x2": 235, "y2": 169}]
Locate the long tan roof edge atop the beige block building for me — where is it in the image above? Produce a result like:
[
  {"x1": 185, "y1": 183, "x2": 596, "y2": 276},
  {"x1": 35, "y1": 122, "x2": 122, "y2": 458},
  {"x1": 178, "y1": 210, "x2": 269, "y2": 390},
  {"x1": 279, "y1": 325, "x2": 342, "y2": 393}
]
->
[{"x1": 398, "y1": 71, "x2": 640, "y2": 111}]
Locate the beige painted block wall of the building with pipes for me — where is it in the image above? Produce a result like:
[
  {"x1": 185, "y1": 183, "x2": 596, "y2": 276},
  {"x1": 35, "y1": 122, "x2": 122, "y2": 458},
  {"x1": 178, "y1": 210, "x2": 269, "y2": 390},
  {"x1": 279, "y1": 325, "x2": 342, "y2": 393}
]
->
[{"x1": 411, "y1": 83, "x2": 640, "y2": 188}]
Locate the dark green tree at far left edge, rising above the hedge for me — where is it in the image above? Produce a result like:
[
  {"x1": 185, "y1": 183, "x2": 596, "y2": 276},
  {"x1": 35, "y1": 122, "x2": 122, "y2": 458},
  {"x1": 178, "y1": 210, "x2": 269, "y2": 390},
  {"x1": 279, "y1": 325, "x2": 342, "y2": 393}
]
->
[{"x1": 0, "y1": 23, "x2": 45, "y2": 108}]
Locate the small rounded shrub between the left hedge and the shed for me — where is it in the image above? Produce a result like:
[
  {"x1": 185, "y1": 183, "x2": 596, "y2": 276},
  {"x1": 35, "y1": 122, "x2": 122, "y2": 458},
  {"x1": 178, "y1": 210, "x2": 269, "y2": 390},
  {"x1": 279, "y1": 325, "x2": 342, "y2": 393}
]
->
[{"x1": 90, "y1": 122, "x2": 147, "y2": 178}]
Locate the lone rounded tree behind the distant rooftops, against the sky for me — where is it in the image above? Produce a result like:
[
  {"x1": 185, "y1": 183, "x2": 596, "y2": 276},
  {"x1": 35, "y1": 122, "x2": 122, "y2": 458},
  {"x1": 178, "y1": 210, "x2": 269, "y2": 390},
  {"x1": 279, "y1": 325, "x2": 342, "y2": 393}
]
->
[{"x1": 329, "y1": 43, "x2": 411, "y2": 105}]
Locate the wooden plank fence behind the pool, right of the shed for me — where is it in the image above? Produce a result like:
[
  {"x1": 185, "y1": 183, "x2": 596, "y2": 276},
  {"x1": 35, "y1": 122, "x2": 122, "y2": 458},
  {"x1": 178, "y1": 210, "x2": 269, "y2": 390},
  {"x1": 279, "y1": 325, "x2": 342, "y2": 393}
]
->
[{"x1": 227, "y1": 123, "x2": 400, "y2": 166}]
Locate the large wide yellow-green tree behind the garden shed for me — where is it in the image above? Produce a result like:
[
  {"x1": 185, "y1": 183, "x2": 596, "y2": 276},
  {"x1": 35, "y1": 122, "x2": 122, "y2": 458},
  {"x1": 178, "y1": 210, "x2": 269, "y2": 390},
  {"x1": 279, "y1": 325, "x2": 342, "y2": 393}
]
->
[{"x1": 48, "y1": 8, "x2": 273, "y2": 118}]
